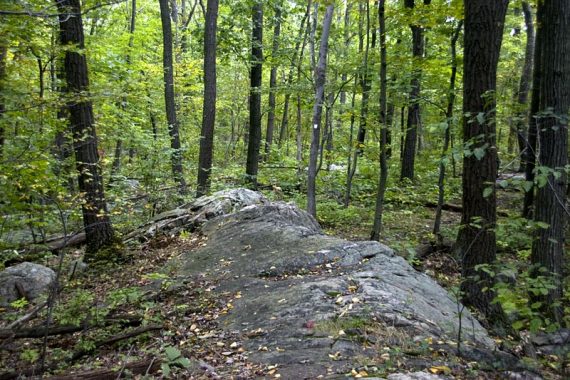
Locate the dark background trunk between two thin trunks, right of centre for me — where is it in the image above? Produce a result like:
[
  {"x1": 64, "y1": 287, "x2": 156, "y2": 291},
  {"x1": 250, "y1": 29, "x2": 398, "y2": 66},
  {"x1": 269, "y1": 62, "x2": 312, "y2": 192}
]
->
[{"x1": 400, "y1": 0, "x2": 431, "y2": 180}]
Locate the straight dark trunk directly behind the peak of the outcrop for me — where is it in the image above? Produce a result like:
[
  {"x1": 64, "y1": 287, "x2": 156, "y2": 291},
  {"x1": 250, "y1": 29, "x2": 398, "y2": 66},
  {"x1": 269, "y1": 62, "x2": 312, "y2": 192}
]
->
[{"x1": 245, "y1": 0, "x2": 263, "y2": 189}]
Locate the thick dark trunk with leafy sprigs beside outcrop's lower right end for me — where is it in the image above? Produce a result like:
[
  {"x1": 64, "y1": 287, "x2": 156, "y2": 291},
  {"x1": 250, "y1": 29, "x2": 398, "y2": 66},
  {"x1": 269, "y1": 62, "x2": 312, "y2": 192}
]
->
[{"x1": 456, "y1": 0, "x2": 508, "y2": 324}]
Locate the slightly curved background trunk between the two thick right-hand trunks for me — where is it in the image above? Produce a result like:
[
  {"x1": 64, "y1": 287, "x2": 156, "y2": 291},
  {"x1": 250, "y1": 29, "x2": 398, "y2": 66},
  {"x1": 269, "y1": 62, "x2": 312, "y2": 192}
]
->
[{"x1": 514, "y1": 1, "x2": 535, "y2": 171}]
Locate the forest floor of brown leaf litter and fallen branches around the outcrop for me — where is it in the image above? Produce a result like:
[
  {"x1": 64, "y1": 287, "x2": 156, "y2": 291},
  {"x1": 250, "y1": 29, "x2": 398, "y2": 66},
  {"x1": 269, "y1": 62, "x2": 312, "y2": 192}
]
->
[{"x1": 0, "y1": 186, "x2": 569, "y2": 380}]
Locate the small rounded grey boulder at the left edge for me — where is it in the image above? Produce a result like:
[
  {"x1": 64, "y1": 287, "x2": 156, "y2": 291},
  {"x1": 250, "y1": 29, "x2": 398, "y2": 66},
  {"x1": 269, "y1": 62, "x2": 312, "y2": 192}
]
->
[{"x1": 0, "y1": 262, "x2": 56, "y2": 306}]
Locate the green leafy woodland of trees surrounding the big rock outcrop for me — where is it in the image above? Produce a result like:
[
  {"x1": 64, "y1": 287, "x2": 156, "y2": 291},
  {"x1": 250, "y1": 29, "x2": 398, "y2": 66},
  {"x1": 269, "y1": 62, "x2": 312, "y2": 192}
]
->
[{"x1": 0, "y1": 0, "x2": 570, "y2": 378}]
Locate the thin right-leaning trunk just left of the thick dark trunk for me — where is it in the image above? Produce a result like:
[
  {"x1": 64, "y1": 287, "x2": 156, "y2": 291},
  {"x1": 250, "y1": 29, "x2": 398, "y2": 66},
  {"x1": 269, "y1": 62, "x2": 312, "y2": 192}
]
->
[{"x1": 433, "y1": 20, "x2": 463, "y2": 241}]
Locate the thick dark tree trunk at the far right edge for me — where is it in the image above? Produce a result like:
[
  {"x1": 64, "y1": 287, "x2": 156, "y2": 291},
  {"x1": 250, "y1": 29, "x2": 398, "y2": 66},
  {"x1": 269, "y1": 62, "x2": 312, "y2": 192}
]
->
[{"x1": 531, "y1": 0, "x2": 570, "y2": 322}]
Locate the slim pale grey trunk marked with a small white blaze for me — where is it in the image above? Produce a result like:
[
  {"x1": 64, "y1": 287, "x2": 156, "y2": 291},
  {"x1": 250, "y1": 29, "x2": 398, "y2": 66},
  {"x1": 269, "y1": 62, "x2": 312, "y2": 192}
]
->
[{"x1": 307, "y1": 4, "x2": 334, "y2": 217}]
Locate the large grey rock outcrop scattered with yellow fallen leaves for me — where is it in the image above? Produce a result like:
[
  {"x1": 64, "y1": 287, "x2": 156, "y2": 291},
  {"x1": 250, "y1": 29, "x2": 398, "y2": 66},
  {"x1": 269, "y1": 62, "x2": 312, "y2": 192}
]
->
[{"x1": 174, "y1": 197, "x2": 494, "y2": 378}]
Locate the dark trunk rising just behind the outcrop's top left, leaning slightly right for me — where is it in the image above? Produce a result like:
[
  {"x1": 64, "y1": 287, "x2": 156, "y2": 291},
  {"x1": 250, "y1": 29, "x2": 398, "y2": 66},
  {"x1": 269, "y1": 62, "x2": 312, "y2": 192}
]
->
[{"x1": 196, "y1": 0, "x2": 218, "y2": 197}]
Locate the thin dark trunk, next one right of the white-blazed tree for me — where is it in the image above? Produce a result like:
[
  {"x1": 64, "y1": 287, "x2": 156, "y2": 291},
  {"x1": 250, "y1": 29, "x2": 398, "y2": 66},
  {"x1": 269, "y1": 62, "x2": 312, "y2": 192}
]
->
[{"x1": 370, "y1": 0, "x2": 388, "y2": 241}]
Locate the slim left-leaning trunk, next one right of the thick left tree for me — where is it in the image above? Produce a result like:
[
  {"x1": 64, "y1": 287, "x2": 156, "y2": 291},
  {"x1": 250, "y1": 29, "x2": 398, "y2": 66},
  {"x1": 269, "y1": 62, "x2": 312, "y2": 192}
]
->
[{"x1": 158, "y1": 0, "x2": 186, "y2": 194}]
